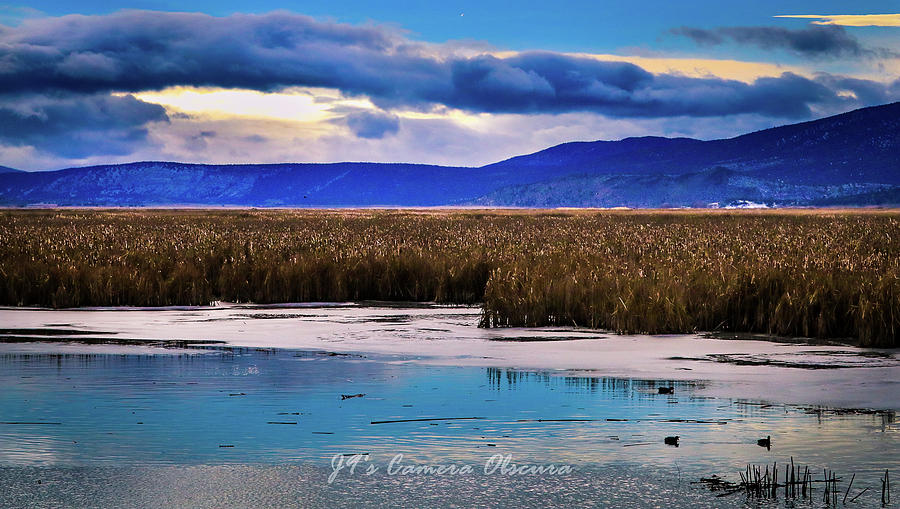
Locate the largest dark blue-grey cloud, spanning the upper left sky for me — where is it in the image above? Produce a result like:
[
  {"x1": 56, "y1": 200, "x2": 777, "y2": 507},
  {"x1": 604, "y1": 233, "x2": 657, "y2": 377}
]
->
[{"x1": 0, "y1": 11, "x2": 439, "y2": 96}]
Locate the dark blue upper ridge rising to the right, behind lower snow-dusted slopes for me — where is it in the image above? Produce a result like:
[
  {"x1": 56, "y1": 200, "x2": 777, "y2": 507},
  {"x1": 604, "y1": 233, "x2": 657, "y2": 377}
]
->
[{"x1": 486, "y1": 102, "x2": 900, "y2": 184}]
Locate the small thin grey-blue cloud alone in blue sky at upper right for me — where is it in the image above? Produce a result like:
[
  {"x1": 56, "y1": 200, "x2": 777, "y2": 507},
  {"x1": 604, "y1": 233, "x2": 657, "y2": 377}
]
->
[{"x1": 671, "y1": 25, "x2": 891, "y2": 58}]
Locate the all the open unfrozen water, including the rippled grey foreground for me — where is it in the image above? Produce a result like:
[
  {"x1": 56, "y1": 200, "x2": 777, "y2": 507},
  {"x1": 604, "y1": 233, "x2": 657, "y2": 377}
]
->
[{"x1": 0, "y1": 346, "x2": 900, "y2": 507}]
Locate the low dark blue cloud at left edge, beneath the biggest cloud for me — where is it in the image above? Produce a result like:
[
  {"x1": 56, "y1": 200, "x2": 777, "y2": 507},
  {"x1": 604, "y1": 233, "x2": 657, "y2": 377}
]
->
[{"x1": 0, "y1": 91, "x2": 168, "y2": 158}]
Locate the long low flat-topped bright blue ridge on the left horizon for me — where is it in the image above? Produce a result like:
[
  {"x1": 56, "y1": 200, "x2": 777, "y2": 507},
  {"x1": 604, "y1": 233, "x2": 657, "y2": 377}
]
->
[{"x1": 0, "y1": 162, "x2": 492, "y2": 207}]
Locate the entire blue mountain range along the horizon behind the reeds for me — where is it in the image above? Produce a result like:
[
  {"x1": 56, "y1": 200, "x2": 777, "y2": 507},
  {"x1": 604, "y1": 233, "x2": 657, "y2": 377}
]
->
[{"x1": 0, "y1": 103, "x2": 900, "y2": 207}]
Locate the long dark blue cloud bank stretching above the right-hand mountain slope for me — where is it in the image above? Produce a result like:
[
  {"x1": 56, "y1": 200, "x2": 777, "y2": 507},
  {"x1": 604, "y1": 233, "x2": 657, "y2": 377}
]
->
[{"x1": 439, "y1": 53, "x2": 884, "y2": 118}]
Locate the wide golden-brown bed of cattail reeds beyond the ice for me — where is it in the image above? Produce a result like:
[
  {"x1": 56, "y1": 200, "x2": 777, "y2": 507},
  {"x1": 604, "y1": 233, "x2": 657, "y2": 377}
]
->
[{"x1": 0, "y1": 206, "x2": 900, "y2": 346}]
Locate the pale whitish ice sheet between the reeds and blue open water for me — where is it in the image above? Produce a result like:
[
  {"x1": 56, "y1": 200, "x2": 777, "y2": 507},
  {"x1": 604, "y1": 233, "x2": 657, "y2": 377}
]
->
[{"x1": 0, "y1": 303, "x2": 900, "y2": 410}]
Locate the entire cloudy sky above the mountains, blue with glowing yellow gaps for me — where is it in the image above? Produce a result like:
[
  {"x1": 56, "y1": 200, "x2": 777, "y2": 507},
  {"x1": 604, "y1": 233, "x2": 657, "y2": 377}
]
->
[{"x1": 0, "y1": 0, "x2": 900, "y2": 170}]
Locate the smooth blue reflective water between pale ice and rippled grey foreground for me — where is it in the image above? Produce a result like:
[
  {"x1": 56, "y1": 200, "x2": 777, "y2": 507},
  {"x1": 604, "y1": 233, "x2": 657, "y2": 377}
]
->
[{"x1": 0, "y1": 348, "x2": 900, "y2": 476}]
